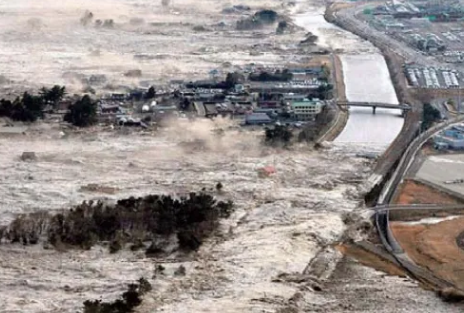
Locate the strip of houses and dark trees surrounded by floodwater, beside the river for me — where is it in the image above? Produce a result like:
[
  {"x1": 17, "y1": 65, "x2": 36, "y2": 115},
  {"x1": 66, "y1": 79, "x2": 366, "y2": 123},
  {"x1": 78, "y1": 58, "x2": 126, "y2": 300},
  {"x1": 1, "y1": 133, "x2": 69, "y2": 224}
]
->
[{"x1": 0, "y1": 64, "x2": 335, "y2": 140}]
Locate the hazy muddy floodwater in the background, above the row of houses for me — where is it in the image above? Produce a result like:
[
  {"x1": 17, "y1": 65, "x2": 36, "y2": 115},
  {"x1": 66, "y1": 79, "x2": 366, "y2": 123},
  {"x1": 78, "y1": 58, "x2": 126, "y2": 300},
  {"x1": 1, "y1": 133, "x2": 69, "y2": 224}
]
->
[{"x1": 0, "y1": 0, "x2": 304, "y2": 90}]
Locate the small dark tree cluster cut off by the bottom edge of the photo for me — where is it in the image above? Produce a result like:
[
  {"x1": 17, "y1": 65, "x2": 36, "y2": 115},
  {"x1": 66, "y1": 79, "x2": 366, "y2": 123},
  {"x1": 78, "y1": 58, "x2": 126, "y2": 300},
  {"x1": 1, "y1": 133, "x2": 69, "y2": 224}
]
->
[{"x1": 83, "y1": 277, "x2": 152, "y2": 313}]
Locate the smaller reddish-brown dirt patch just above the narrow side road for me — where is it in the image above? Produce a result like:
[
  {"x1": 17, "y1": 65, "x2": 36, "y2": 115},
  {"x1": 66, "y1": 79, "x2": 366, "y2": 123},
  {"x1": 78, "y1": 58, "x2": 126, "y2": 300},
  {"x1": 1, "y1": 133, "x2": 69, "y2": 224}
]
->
[{"x1": 394, "y1": 179, "x2": 461, "y2": 204}]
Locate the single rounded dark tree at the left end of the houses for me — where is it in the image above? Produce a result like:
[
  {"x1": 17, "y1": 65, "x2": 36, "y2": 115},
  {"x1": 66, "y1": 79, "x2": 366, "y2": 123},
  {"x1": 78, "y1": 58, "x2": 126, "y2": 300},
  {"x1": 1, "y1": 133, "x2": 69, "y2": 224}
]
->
[{"x1": 64, "y1": 95, "x2": 97, "y2": 127}]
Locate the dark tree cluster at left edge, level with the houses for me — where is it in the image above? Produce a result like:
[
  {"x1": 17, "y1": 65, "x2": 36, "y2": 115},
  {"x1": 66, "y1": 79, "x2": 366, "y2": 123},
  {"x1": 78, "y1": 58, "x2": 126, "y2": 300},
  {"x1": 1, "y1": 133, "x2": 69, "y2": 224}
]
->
[{"x1": 0, "y1": 86, "x2": 66, "y2": 122}]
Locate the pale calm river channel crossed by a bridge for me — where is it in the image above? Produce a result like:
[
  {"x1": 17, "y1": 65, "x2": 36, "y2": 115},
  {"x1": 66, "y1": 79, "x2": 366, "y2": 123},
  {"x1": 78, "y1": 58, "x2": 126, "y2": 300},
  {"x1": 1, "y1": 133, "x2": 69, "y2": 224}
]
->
[{"x1": 294, "y1": 8, "x2": 404, "y2": 152}]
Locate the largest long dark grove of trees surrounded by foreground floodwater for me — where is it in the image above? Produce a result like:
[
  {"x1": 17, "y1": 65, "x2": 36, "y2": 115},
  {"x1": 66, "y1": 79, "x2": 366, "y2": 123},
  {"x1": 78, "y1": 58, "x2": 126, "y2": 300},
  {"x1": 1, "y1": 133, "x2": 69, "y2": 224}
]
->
[{"x1": 4, "y1": 190, "x2": 233, "y2": 252}]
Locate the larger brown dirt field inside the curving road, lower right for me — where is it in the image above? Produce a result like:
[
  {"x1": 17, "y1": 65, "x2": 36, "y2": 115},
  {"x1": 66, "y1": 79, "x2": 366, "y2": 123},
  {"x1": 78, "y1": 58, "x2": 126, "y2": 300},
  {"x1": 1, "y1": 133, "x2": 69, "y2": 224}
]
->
[{"x1": 391, "y1": 217, "x2": 464, "y2": 290}]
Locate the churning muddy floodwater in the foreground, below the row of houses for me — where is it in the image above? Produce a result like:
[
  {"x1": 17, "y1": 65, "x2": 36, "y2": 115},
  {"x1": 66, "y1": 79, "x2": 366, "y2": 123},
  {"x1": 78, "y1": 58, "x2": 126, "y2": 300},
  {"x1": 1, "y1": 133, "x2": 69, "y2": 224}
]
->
[{"x1": 0, "y1": 121, "x2": 369, "y2": 312}]
